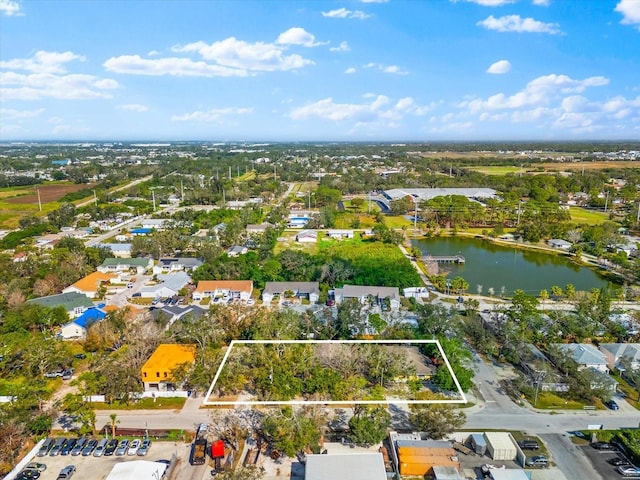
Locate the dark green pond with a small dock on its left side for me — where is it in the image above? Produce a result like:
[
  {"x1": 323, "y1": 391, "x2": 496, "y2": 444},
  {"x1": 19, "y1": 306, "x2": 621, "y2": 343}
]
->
[{"x1": 411, "y1": 237, "x2": 608, "y2": 296}]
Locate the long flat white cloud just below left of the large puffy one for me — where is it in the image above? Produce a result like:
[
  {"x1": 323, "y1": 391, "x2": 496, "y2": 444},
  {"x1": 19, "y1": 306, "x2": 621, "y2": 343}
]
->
[{"x1": 103, "y1": 55, "x2": 248, "y2": 77}]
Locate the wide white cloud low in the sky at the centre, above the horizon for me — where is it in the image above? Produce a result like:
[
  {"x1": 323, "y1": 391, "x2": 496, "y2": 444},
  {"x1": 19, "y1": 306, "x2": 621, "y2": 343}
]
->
[{"x1": 289, "y1": 94, "x2": 435, "y2": 126}]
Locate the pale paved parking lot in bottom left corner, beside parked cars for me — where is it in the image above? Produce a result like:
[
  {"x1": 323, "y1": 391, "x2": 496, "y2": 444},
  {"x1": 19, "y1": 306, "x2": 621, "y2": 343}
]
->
[{"x1": 16, "y1": 441, "x2": 200, "y2": 480}]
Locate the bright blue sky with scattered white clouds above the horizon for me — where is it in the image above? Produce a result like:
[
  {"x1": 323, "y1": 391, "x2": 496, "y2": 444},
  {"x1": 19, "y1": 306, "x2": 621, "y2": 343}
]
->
[{"x1": 0, "y1": 0, "x2": 640, "y2": 141}]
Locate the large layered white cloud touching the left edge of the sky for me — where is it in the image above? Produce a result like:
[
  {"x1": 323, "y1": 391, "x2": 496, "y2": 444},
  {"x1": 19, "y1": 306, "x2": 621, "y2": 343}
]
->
[{"x1": 0, "y1": 51, "x2": 119, "y2": 100}]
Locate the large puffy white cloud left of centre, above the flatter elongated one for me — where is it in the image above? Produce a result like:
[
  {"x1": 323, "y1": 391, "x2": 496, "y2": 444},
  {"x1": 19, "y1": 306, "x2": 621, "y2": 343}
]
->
[{"x1": 172, "y1": 34, "x2": 313, "y2": 72}]
